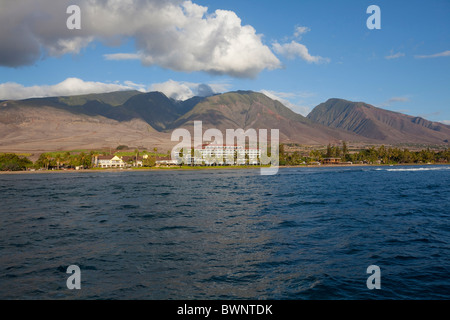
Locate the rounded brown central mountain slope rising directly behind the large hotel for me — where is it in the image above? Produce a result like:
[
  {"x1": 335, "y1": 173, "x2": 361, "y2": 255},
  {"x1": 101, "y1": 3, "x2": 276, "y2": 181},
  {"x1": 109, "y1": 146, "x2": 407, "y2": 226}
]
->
[{"x1": 170, "y1": 91, "x2": 357, "y2": 144}]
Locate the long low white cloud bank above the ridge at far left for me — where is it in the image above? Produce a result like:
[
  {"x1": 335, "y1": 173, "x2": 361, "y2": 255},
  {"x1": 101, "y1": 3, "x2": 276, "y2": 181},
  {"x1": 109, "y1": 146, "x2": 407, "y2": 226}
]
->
[{"x1": 0, "y1": 78, "x2": 142, "y2": 100}]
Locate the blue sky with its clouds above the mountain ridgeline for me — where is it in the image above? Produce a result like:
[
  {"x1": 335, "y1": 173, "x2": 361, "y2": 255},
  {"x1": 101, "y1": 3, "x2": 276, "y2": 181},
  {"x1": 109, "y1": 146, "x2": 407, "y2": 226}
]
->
[{"x1": 0, "y1": 0, "x2": 450, "y2": 123}]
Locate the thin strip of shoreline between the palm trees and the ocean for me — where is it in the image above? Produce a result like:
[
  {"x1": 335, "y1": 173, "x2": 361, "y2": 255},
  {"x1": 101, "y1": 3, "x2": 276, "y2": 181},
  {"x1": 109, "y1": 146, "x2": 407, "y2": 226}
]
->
[{"x1": 0, "y1": 163, "x2": 450, "y2": 175}]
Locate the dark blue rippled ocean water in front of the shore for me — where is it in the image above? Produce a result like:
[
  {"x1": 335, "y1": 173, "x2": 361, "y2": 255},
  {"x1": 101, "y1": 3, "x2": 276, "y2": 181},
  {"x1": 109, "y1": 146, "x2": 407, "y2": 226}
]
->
[{"x1": 0, "y1": 166, "x2": 450, "y2": 300}]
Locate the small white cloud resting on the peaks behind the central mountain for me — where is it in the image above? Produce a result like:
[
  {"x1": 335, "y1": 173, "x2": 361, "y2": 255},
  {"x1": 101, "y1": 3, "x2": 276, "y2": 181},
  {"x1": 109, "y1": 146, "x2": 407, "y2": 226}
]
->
[{"x1": 149, "y1": 80, "x2": 229, "y2": 100}]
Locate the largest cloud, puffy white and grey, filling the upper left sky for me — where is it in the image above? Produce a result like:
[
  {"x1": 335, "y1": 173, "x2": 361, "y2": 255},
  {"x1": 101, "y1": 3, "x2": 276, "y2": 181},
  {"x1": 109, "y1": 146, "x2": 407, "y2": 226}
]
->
[{"x1": 0, "y1": 0, "x2": 281, "y2": 78}]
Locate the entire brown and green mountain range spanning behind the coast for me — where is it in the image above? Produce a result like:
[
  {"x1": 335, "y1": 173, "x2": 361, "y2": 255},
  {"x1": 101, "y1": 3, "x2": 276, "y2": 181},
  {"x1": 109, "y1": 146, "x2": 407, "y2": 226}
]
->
[{"x1": 0, "y1": 91, "x2": 450, "y2": 153}]
